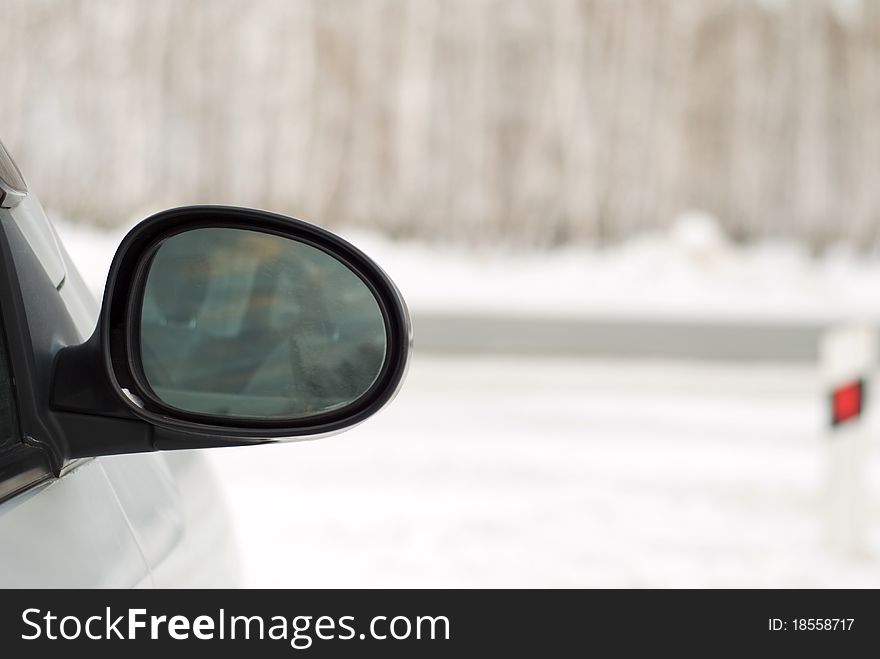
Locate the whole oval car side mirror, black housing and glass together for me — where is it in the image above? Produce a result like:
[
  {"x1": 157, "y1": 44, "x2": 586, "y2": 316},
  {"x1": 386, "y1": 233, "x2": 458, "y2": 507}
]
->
[{"x1": 51, "y1": 206, "x2": 411, "y2": 461}]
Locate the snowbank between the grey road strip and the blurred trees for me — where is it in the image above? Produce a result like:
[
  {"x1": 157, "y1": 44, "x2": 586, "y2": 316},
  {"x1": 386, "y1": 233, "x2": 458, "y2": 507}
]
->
[{"x1": 56, "y1": 214, "x2": 880, "y2": 322}]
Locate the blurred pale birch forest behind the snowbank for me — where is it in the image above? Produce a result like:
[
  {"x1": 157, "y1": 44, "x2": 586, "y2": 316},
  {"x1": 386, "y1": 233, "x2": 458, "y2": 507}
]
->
[{"x1": 0, "y1": 0, "x2": 880, "y2": 248}]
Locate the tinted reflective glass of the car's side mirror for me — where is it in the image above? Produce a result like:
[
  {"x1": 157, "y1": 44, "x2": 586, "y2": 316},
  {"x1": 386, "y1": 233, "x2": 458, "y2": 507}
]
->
[{"x1": 140, "y1": 228, "x2": 386, "y2": 419}]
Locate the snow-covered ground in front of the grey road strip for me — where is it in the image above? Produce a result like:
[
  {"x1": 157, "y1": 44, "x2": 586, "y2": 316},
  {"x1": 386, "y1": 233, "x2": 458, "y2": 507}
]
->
[{"x1": 211, "y1": 356, "x2": 880, "y2": 587}]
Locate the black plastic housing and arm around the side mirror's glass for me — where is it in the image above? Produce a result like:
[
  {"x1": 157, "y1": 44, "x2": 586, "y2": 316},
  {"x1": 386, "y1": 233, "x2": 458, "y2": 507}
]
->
[{"x1": 50, "y1": 206, "x2": 412, "y2": 463}]
